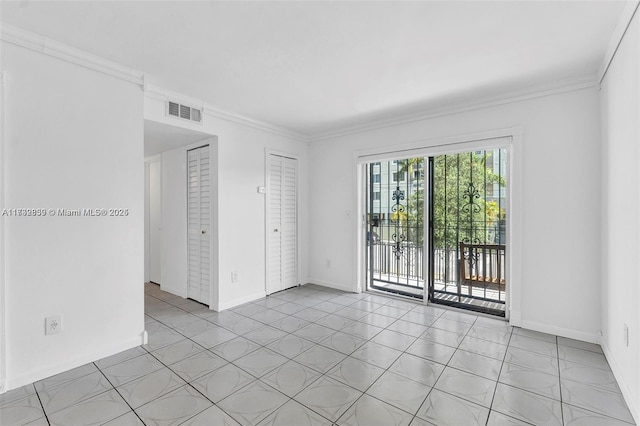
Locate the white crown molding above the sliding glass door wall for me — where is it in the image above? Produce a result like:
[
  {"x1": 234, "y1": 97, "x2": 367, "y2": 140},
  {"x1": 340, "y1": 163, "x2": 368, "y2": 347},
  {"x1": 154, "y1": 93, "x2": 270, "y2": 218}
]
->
[{"x1": 308, "y1": 75, "x2": 599, "y2": 142}]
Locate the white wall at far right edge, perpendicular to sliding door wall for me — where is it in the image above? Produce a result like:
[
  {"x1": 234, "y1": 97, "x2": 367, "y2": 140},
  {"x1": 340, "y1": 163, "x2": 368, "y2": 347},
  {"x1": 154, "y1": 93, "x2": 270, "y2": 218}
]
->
[{"x1": 601, "y1": 10, "x2": 640, "y2": 422}]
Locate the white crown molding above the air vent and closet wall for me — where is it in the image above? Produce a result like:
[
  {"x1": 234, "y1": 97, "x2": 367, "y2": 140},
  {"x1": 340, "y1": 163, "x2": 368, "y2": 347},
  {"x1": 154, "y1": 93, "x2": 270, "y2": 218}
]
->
[{"x1": 144, "y1": 84, "x2": 309, "y2": 142}]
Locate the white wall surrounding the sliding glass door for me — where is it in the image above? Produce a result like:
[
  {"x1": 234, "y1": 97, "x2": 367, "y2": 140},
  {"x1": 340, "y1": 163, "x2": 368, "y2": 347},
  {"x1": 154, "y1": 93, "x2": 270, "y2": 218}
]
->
[{"x1": 309, "y1": 88, "x2": 600, "y2": 341}]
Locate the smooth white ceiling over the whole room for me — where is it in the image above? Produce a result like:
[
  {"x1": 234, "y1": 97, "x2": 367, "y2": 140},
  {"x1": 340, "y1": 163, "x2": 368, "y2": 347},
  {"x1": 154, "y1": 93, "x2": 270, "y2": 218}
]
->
[{"x1": 1, "y1": 0, "x2": 625, "y2": 135}]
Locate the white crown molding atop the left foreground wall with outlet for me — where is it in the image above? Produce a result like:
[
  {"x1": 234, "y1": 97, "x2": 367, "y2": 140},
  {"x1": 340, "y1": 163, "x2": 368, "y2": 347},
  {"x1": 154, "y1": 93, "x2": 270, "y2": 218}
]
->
[{"x1": 0, "y1": 22, "x2": 144, "y2": 86}]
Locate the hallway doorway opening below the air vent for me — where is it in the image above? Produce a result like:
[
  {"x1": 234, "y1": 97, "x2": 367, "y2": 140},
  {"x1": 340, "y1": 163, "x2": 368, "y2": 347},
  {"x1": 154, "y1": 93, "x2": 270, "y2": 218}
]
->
[{"x1": 144, "y1": 120, "x2": 217, "y2": 308}]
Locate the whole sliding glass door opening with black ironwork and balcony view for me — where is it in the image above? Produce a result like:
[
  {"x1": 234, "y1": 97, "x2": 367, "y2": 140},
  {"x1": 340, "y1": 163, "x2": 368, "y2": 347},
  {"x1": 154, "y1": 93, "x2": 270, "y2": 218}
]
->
[{"x1": 366, "y1": 148, "x2": 508, "y2": 317}]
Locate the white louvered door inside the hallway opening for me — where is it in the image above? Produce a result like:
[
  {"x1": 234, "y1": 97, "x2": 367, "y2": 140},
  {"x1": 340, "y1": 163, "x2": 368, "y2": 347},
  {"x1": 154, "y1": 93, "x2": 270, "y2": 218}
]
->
[{"x1": 187, "y1": 146, "x2": 211, "y2": 305}]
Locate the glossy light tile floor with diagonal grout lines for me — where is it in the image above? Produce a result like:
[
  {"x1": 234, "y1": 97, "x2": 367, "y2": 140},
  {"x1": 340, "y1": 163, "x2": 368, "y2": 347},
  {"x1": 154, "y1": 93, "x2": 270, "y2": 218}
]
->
[{"x1": 0, "y1": 284, "x2": 633, "y2": 426}]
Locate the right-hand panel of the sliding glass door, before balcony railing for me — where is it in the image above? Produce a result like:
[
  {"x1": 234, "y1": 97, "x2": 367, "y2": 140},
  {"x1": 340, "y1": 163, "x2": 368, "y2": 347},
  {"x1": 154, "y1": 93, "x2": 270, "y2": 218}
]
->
[{"x1": 424, "y1": 150, "x2": 511, "y2": 318}]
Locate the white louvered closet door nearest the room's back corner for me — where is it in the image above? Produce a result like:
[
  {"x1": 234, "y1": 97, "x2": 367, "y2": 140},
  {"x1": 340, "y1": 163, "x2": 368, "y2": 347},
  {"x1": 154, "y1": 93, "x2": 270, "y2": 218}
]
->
[{"x1": 267, "y1": 155, "x2": 298, "y2": 294}]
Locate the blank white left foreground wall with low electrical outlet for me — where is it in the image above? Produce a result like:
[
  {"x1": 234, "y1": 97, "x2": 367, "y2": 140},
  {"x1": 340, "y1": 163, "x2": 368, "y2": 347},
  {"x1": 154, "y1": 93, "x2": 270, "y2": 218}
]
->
[{"x1": 1, "y1": 42, "x2": 144, "y2": 389}]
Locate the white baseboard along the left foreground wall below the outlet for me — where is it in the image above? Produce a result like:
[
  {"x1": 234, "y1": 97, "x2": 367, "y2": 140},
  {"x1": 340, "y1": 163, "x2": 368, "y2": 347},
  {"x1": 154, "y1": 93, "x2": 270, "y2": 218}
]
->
[{"x1": 6, "y1": 331, "x2": 147, "y2": 391}]
